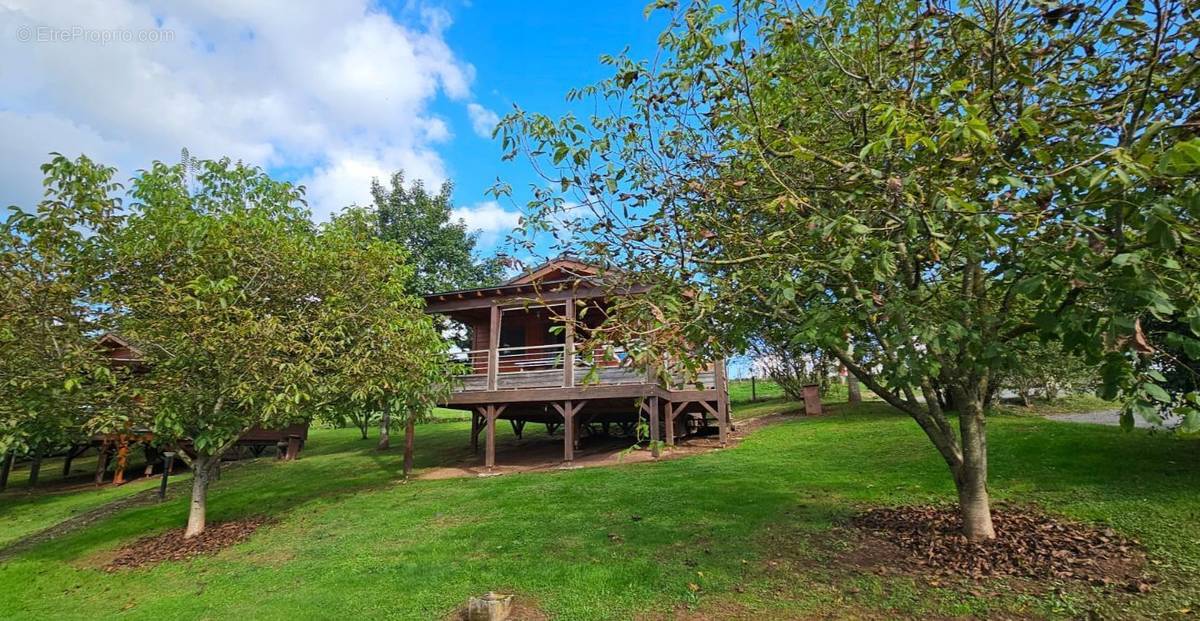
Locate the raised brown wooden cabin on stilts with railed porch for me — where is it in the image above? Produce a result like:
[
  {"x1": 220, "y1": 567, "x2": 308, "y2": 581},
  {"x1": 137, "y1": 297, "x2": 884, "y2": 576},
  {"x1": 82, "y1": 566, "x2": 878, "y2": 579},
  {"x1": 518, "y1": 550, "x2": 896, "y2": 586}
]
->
[{"x1": 425, "y1": 258, "x2": 730, "y2": 470}]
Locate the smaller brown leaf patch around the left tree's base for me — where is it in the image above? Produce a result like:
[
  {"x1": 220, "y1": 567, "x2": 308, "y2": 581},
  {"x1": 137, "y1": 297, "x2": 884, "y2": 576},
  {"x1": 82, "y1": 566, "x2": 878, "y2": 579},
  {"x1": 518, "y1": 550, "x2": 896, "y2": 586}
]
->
[{"x1": 104, "y1": 517, "x2": 270, "y2": 572}]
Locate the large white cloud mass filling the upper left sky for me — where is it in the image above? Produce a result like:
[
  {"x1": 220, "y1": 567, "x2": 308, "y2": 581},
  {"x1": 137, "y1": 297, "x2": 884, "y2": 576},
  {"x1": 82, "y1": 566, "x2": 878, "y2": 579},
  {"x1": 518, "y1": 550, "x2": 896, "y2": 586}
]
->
[{"x1": 0, "y1": 0, "x2": 474, "y2": 217}]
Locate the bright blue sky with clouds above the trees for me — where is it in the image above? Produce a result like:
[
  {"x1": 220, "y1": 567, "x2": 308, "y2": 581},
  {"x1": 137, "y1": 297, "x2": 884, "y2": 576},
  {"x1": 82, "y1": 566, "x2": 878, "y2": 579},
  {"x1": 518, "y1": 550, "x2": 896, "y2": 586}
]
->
[{"x1": 0, "y1": 0, "x2": 665, "y2": 258}]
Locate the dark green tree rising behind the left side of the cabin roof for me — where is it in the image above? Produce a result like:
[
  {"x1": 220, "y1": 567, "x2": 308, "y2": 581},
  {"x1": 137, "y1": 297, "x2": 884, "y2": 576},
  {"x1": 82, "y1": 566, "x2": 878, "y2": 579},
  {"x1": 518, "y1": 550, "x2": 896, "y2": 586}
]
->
[{"x1": 371, "y1": 171, "x2": 504, "y2": 450}]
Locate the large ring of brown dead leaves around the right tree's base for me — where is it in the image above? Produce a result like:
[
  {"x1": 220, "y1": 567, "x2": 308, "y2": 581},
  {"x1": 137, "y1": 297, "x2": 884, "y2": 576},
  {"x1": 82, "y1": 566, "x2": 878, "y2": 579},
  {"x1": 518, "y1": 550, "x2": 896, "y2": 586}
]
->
[{"x1": 844, "y1": 506, "x2": 1153, "y2": 593}]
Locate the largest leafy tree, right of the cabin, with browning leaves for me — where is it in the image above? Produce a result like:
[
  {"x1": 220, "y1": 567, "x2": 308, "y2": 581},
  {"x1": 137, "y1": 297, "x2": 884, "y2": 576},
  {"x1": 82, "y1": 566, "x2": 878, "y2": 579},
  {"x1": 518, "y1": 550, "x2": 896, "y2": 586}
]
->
[{"x1": 494, "y1": 0, "x2": 1200, "y2": 541}]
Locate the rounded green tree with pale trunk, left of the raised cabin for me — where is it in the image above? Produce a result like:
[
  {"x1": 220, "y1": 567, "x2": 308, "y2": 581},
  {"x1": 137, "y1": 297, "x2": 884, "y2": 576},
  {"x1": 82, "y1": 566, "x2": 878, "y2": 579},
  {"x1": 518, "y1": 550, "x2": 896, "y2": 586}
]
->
[{"x1": 103, "y1": 159, "x2": 438, "y2": 537}]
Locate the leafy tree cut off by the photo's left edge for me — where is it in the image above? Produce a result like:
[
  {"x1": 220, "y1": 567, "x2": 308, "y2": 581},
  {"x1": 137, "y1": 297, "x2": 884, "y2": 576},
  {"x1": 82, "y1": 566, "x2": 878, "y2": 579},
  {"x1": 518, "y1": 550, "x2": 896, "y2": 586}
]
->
[{"x1": 0, "y1": 153, "x2": 120, "y2": 478}]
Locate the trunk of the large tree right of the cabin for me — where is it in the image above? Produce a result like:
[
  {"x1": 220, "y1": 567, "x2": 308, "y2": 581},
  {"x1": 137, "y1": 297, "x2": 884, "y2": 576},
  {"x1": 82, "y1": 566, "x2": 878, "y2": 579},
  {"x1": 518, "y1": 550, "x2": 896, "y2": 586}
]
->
[{"x1": 954, "y1": 397, "x2": 996, "y2": 542}]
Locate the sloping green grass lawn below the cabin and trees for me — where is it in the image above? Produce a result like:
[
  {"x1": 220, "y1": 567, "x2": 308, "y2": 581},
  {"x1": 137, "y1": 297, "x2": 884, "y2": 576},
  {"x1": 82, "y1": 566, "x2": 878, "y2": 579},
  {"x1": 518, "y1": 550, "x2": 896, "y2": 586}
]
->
[{"x1": 0, "y1": 400, "x2": 1200, "y2": 620}]
